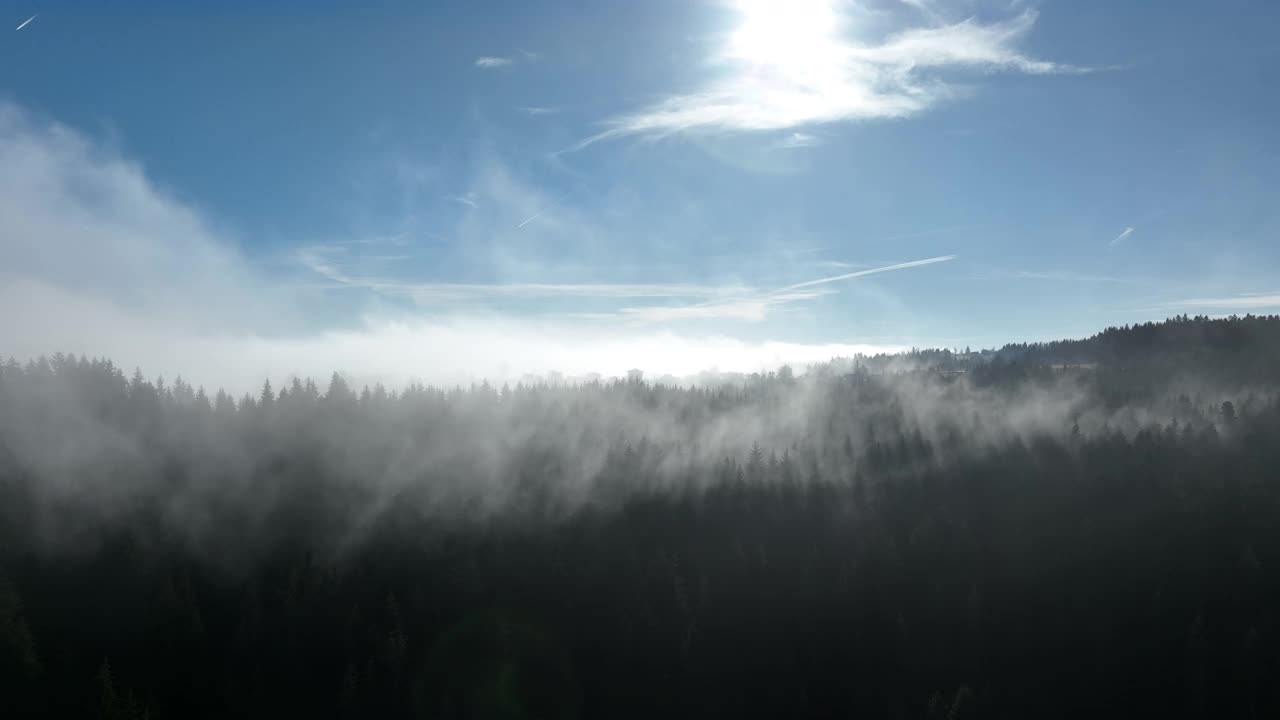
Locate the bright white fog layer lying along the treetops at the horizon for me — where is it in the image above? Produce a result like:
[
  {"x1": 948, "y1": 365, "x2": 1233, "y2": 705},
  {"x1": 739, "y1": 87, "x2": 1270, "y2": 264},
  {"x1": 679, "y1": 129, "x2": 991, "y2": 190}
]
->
[{"x1": 0, "y1": 278, "x2": 901, "y2": 393}]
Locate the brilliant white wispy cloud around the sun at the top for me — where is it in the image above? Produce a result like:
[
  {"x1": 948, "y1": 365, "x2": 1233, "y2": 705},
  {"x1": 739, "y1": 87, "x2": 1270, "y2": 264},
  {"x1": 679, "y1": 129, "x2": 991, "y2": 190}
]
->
[{"x1": 573, "y1": 0, "x2": 1084, "y2": 150}]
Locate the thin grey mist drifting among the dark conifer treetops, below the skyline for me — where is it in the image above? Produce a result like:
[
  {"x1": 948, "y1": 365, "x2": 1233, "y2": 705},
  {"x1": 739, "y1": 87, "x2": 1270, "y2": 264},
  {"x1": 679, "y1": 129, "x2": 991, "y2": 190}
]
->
[{"x1": 0, "y1": 325, "x2": 1267, "y2": 566}]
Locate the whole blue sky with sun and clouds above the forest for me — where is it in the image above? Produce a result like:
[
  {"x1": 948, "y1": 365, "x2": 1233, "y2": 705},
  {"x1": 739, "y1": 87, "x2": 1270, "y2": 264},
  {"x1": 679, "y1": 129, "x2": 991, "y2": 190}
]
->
[{"x1": 0, "y1": 0, "x2": 1280, "y2": 382}]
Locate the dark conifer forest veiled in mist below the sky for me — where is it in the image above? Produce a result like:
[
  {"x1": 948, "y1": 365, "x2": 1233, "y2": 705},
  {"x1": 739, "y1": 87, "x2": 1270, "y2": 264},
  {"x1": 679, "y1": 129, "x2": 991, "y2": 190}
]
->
[{"x1": 0, "y1": 315, "x2": 1280, "y2": 720}]
